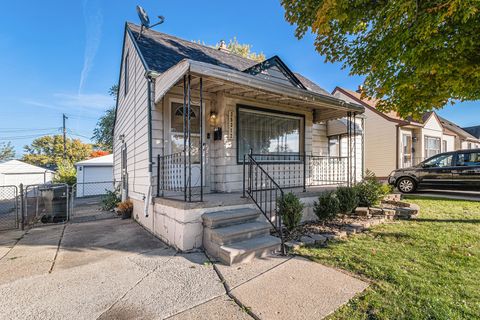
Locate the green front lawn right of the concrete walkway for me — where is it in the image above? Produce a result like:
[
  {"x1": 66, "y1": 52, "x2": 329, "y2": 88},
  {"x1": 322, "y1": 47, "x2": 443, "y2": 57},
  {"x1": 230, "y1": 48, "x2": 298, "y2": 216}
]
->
[{"x1": 299, "y1": 196, "x2": 480, "y2": 319}]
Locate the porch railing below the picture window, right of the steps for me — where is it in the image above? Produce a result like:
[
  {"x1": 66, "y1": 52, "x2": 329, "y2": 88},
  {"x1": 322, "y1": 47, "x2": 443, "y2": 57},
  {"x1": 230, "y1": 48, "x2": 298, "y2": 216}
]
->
[{"x1": 250, "y1": 154, "x2": 349, "y2": 190}]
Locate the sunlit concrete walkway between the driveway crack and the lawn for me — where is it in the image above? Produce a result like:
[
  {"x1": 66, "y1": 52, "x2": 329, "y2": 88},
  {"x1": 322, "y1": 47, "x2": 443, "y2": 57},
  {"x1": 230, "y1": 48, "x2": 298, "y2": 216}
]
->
[{"x1": 216, "y1": 256, "x2": 368, "y2": 319}]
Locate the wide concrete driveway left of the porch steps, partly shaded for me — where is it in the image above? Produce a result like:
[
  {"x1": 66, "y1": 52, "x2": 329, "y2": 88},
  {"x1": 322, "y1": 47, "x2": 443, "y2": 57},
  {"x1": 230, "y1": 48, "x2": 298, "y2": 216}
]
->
[{"x1": 0, "y1": 219, "x2": 249, "y2": 319}]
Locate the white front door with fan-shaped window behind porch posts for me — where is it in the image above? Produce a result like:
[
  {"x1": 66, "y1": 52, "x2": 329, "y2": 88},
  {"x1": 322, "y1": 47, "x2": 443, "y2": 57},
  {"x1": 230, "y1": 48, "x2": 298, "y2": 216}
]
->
[{"x1": 170, "y1": 102, "x2": 205, "y2": 187}]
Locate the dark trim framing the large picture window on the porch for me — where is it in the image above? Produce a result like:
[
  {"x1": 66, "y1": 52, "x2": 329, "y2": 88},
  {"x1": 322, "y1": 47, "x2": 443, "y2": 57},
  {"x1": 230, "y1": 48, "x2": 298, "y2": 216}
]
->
[{"x1": 235, "y1": 103, "x2": 306, "y2": 164}]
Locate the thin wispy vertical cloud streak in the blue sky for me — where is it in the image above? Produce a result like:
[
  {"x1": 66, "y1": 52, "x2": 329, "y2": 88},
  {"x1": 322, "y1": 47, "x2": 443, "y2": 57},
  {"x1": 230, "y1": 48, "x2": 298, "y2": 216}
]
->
[{"x1": 78, "y1": 0, "x2": 103, "y2": 95}]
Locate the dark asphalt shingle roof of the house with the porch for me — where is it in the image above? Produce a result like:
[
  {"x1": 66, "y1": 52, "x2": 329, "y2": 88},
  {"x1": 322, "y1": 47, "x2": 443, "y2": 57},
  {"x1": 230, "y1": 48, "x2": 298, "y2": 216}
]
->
[{"x1": 127, "y1": 22, "x2": 331, "y2": 96}]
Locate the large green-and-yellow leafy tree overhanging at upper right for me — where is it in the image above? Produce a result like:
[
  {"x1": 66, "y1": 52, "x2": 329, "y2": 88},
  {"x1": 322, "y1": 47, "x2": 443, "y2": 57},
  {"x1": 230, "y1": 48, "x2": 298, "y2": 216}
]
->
[{"x1": 282, "y1": 0, "x2": 480, "y2": 118}]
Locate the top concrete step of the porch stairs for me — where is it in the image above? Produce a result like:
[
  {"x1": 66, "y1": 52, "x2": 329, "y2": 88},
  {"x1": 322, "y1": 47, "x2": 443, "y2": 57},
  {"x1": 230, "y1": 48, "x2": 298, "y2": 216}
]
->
[{"x1": 202, "y1": 208, "x2": 260, "y2": 228}]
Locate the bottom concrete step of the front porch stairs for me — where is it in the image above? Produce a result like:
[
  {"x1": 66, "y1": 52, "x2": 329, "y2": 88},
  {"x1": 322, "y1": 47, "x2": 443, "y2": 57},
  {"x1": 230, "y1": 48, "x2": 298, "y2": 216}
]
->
[{"x1": 217, "y1": 236, "x2": 281, "y2": 265}]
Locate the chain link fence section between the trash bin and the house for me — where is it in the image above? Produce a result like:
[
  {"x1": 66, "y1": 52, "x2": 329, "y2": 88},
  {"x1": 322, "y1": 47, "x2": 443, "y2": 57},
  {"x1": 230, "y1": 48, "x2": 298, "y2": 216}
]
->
[{"x1": 70, "y1": 181, "x2": 119, "y2": 222}]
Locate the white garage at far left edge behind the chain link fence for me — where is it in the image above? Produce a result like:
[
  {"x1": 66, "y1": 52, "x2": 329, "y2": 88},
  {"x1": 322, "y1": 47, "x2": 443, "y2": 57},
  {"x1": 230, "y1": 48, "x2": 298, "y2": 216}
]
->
[{"x1": 0, "y1": 160, "x2": 55, "y2": 187}]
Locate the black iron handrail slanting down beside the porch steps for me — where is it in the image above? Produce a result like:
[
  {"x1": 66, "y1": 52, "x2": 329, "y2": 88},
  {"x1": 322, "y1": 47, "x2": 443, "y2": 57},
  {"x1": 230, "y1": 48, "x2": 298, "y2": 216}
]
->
[{"x1": 244, "y1": 155, "x2": 285, "y2": 254}]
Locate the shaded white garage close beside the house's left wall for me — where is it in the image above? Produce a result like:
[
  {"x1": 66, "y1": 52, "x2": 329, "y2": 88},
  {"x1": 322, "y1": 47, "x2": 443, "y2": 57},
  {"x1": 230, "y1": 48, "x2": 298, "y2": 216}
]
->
[{"x1": 75, "y1": 154, "x2": 113, "y2": 197}]
